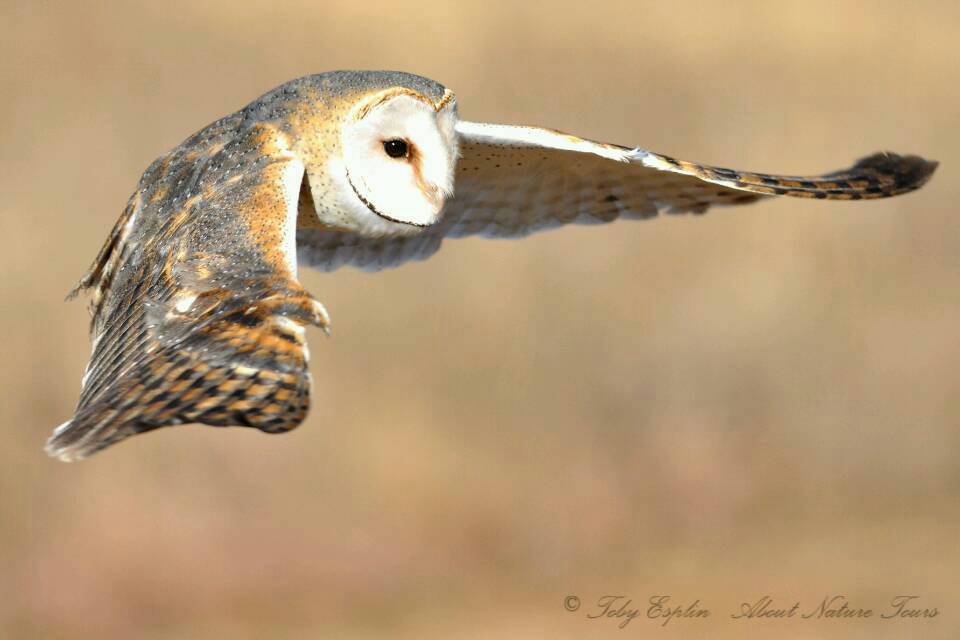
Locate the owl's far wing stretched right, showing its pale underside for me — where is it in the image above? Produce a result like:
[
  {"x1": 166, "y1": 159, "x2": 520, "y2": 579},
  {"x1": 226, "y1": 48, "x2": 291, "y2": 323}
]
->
[{"x1": 298, "y1": 122, "x2": 937, "y2": 270}]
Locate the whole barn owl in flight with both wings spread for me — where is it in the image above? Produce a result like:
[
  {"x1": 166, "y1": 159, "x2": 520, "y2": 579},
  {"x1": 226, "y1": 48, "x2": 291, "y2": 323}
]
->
[{"x1": 46, "y1": 71, "x2": 937, "y2": 460}]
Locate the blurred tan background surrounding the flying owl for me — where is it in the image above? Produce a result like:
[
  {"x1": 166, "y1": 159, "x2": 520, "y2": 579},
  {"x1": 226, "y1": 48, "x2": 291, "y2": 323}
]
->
[{"x1": 0, "y1": 0, "x2": 960, "y2": 639}]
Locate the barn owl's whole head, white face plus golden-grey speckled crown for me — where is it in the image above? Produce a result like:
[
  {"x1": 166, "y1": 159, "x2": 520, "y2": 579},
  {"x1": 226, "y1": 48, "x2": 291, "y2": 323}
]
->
[{"x1": 290, "y1": 72, "x2": 458, "y2": 235}]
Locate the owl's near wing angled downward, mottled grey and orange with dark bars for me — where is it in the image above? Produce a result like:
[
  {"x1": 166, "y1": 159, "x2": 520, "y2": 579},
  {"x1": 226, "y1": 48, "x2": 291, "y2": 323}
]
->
[{"x1": 47, "y1": 118, "x2": 327, "y2": 460}]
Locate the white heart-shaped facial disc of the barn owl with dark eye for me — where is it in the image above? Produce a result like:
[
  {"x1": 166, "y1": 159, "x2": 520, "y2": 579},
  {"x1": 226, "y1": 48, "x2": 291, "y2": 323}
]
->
[{"x1": 330, "y1": 93, "x2": 457, "y2": 233}]
